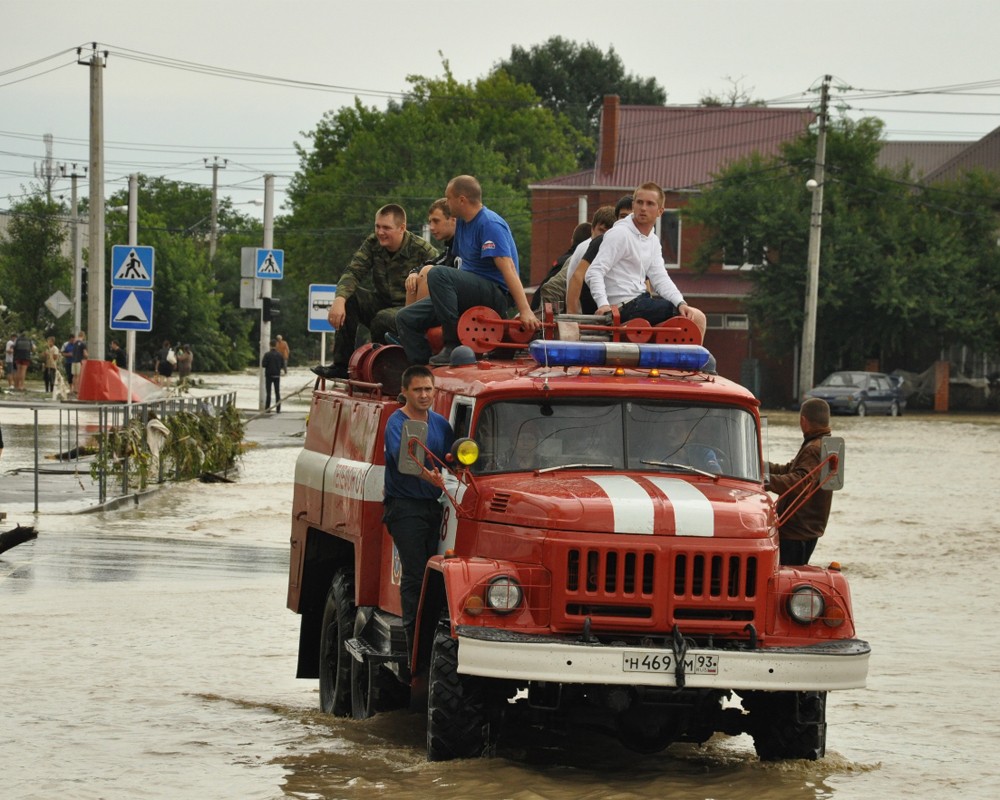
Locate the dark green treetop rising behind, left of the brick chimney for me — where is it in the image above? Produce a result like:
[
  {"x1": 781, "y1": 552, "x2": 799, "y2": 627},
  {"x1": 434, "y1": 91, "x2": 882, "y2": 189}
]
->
[{"x1": 493, "y1": 36, "x2": 667, "y2": 164}]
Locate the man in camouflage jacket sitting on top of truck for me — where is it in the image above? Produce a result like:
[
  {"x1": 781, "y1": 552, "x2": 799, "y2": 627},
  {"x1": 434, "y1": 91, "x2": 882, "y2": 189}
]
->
[{"x1": 312, "y1": 203, "x2": 437, "y2": 378}]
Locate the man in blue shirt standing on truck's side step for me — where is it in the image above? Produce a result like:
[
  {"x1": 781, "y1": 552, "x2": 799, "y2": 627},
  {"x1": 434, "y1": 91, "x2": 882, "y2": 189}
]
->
[{"x1": 382, "y1": 365, "x2": 455, "y2": 652}]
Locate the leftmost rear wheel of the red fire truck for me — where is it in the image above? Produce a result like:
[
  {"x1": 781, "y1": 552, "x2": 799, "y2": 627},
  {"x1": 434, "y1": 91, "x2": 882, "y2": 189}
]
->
[{"x1": 319, "y1": 569, "x2": 355, "y2": 717}]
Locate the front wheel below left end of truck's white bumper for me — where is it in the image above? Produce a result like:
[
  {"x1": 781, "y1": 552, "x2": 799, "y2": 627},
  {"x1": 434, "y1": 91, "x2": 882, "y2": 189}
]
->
[{"x1": 427, "y1": 622, "x2": 500, "y2": 761}]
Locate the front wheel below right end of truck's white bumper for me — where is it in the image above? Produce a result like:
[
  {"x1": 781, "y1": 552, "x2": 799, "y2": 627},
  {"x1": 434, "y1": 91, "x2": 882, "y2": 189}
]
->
[{"x1": 743, "y1": 692, "x2": 826, "y2": 761}]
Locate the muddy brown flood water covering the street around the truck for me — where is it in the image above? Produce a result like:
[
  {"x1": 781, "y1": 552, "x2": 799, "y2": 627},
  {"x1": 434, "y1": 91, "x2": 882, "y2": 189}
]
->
[{"x1": 0, "y1": 371, "x2": 1000, "y2": 800}]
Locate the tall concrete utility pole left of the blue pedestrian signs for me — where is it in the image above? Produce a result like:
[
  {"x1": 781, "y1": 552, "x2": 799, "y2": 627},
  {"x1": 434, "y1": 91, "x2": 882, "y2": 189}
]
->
[{"x1": 76, "y1": 42, "x2": 108, "y2": 358}]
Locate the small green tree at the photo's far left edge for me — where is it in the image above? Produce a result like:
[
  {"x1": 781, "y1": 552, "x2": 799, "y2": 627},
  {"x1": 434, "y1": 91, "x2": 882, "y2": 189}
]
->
[{"x1": 0, "y1": 194, "x2": 72, "y2": 330}]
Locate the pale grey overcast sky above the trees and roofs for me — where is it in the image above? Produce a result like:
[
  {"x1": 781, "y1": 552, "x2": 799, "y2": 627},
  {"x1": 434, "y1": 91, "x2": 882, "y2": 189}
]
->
[{"x1": 0, "y1": 0, "x2": 1000, "y2": 216}]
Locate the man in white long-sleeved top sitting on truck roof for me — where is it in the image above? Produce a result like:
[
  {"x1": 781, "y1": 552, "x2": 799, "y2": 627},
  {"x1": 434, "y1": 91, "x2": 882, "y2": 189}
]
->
[{"x1": 584, "y1": 183, "x2": 705, "y2": 337}]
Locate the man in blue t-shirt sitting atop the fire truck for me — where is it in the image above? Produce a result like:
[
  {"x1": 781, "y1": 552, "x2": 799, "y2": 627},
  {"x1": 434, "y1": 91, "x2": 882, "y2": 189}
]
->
[{"x1": 396, "y1": 175, "x2": 541, "y2": 366}]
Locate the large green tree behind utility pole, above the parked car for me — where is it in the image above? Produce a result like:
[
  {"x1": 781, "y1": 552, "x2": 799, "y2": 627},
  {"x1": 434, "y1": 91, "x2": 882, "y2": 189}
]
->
[{"x1": 683, "y1": 118, "x2": 1000, "y2": 378}]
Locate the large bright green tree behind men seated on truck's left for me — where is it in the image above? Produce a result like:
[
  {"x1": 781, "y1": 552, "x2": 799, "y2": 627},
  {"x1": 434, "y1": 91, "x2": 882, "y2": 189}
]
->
[{"x1": 275, "y1": 63, "x2": 581, "y2": 358}]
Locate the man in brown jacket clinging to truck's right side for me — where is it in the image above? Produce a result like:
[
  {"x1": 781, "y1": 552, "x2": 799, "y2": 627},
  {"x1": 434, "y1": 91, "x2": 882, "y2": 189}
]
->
[{"x1": 767, "y1": 397, "x2": 833, "y2": 566}]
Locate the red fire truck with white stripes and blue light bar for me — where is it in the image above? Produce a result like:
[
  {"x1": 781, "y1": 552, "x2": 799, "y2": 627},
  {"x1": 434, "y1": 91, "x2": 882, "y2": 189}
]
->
[{"x1": 288, "y1": 308, "x2": 869, "y2": 760}]
